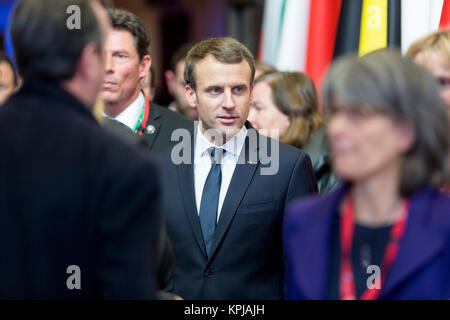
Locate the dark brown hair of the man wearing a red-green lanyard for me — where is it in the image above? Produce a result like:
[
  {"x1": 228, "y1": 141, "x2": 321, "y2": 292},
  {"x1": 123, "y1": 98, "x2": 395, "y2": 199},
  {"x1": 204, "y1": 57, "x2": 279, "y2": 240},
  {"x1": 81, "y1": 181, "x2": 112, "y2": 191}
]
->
[{"x1": 108, "y1": 8, "x2": 151, "y2": 60}]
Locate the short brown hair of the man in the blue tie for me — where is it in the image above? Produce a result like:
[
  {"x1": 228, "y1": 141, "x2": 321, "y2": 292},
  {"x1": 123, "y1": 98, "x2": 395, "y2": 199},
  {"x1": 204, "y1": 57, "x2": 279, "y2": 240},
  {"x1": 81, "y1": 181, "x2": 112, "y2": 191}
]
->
[{"x1": 184, "y1": 37, "x2": 255, "y2": 90}]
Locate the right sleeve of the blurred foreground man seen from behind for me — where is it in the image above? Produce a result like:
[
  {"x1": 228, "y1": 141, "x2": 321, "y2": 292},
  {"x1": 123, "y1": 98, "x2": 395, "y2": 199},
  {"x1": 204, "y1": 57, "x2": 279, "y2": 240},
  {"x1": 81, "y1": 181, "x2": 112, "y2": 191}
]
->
[{"x1": 99, "y1": 159, "x2": 160, "y2": 299}]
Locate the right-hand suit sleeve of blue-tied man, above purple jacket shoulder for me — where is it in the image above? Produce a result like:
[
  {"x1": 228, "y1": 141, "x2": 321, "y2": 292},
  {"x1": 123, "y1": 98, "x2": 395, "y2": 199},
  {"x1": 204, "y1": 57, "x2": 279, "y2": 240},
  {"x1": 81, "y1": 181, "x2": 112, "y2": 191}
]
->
[{"x1": 284, "y1": 152, "x2": 318, "y2": 208}]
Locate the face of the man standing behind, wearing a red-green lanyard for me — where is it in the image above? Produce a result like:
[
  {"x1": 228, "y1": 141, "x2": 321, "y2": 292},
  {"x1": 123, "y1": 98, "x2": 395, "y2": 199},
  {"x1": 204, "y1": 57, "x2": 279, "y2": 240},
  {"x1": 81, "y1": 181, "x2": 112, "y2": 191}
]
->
[{"x1": 103, "y1": 29, "x2": 151, "y2": 107}]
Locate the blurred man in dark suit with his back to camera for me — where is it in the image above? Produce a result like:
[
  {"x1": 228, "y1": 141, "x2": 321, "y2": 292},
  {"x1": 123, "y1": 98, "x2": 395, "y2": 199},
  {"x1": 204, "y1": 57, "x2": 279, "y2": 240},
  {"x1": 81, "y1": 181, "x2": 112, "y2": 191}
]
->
[{"x1": 0, "y1": 0, "x2": 159, "y2": 299}]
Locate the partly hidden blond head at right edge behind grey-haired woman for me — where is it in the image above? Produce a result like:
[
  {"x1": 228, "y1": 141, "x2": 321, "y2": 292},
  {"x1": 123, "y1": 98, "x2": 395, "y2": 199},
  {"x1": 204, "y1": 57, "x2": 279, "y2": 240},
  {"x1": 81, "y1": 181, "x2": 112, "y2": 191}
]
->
[{"x1": 406, "y1": 30, "x2": 450, "y2": 120}]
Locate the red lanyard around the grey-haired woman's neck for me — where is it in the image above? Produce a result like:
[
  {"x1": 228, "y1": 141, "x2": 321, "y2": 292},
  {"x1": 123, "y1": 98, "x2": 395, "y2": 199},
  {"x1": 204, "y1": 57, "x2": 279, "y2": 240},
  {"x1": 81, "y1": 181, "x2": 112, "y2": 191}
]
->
[{"x1": 339, "y1": 197, "x2": 409, "y2": 300}]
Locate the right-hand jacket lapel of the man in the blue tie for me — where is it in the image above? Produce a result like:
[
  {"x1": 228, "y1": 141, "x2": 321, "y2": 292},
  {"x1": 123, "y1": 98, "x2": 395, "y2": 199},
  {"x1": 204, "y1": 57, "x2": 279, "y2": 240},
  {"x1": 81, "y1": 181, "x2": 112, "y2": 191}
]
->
[{"x1": 208, "y1": 128, "x2": 259, "y2": 265}]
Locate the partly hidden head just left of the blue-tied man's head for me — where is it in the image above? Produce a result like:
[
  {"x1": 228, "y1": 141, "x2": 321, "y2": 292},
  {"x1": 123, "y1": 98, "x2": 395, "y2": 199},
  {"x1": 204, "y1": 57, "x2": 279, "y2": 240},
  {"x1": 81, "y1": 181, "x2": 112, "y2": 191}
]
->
[{"x1": 164, "y1": 43, "x2": 198, "y2": 120}]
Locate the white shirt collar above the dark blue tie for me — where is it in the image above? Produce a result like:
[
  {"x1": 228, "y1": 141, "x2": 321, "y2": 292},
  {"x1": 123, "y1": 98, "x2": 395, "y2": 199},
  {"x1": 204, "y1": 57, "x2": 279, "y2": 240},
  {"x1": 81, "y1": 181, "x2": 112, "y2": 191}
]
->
[{"x1": 195, "y1": 122, "x2": 247, "y2": 158}]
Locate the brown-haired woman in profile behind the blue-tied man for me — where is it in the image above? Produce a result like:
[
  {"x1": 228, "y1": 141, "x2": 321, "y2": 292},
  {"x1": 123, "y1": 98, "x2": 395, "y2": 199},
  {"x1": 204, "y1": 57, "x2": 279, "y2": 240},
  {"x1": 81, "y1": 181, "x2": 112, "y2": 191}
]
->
[{"x1": 248, "y1": 72, "x2": 338, "y2": 193}]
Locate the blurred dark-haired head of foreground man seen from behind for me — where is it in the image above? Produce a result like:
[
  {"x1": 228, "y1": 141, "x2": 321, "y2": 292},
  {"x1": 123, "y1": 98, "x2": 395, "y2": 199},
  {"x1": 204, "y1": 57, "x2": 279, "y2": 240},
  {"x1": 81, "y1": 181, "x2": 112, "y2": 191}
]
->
[{"x1": 11, "y1": 0, "x2": 110, "y2": 107}]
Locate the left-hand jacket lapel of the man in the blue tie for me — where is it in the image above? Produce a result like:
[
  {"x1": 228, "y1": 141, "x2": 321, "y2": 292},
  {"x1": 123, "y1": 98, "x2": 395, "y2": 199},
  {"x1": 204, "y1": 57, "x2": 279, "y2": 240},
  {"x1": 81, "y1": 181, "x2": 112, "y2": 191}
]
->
[{"x1": 176, "y1": 128, "x2": 208, "y2": 259}]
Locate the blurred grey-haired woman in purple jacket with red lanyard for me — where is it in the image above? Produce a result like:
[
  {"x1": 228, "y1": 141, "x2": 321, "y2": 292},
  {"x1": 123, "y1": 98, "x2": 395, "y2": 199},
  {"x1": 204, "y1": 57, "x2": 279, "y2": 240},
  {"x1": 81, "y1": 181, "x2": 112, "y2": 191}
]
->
[{"x1": 283, "y1": 50, "x2": 450, "y2": 299}]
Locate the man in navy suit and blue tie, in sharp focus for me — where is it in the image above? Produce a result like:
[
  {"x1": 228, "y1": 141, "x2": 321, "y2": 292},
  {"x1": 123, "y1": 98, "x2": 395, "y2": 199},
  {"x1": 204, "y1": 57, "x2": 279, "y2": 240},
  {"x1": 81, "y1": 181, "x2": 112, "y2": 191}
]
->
[{"x1": 158, "y1": 38, "x2": 317, "y2": 299}]
